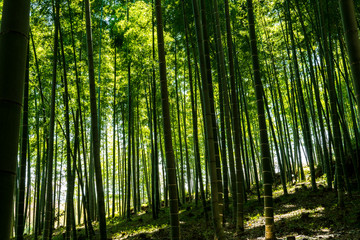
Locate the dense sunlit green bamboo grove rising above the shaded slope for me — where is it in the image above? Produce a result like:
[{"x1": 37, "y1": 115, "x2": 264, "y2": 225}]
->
[{"x1": 4, "y1": 0, "x2": 360, "y2": 239}]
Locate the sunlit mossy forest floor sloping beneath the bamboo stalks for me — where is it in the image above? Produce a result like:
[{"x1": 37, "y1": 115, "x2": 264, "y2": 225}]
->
[{"x1": 47, "y1": 175, "x2": 360, "y2": 240}]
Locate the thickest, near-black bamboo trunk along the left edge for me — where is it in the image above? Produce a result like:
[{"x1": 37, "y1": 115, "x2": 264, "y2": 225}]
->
[{"x1": 0, "y1": 0, "x2": 30, "y2": 236}]
